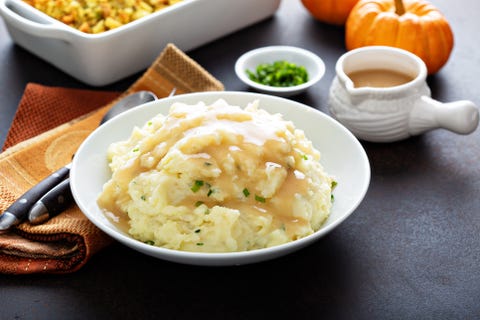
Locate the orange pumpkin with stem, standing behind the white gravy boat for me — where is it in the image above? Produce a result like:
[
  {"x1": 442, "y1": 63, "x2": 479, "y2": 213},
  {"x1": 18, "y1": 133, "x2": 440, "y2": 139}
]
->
[{"x1": 345, "y1": 0, "x2": 454, "y2": 74}]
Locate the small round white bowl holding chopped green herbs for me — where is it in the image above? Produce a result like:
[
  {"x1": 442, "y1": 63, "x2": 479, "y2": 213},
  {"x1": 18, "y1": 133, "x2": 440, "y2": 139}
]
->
[{"x1": 235, "y1": 46, "x2": 325, "y2": 97}]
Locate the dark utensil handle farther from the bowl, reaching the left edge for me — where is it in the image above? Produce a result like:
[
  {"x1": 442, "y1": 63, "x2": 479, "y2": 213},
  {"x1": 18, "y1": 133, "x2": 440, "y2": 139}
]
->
[{"x1": 0, "y1": 164, "x2": 71, "y2": 231}]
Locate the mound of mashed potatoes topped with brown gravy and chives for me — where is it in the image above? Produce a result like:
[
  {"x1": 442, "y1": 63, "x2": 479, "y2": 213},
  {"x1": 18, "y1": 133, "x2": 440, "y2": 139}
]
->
[{"x1": 98, "y1": 100, "x2": 334, "y2": 252}]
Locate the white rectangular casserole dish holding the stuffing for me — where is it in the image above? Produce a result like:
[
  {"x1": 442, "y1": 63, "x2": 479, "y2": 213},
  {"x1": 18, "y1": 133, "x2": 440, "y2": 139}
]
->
[{"x1": 0, "y1": 0, "x2": 281, "y2": 86}]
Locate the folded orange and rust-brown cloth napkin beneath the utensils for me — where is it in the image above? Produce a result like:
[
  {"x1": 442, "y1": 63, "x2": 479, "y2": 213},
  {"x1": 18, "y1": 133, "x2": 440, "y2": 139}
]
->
[{"x1": 0, "y1": 44, "x2": 224, "y2": 274}]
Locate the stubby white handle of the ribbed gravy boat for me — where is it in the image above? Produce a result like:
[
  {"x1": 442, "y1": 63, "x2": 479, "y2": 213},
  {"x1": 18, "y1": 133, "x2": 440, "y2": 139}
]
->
[{"x1": 409, "y1": 96, "x2": 479, "y2": 135}]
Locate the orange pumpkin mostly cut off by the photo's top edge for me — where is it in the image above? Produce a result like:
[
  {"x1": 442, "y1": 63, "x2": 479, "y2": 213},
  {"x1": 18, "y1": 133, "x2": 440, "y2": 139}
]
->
[{"x1": 302, "y1": 0, "x2": 358, "y2": 25}]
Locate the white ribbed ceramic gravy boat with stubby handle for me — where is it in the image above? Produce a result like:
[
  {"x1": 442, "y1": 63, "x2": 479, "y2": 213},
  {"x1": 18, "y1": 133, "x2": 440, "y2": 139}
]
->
[{"x1": 329, "y1": 46, "x2": 479, "y2": 142}]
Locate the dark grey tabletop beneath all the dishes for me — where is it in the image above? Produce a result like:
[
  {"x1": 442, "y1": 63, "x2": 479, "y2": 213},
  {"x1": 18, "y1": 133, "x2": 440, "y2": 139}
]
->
[{"x1": 0, "y1": 0, "x2": 480, "y2": 319}]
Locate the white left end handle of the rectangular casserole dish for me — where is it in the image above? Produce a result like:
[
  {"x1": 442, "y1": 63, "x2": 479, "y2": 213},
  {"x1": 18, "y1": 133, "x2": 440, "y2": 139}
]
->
[{"x1": 0, "y1": 0, "x2": 73, "y2": 41}]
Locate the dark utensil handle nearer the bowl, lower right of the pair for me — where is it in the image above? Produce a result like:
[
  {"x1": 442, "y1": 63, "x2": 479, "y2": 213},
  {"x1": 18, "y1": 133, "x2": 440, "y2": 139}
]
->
[{"x1": 28, "y1": 178, "x2": 73, "y2": 224}]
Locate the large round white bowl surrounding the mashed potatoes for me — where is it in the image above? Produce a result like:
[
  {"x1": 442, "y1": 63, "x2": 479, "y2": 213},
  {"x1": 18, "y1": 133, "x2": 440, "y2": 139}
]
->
[{"x1": 70, "y1": 92, "x2": 370, "y2": 266}]
